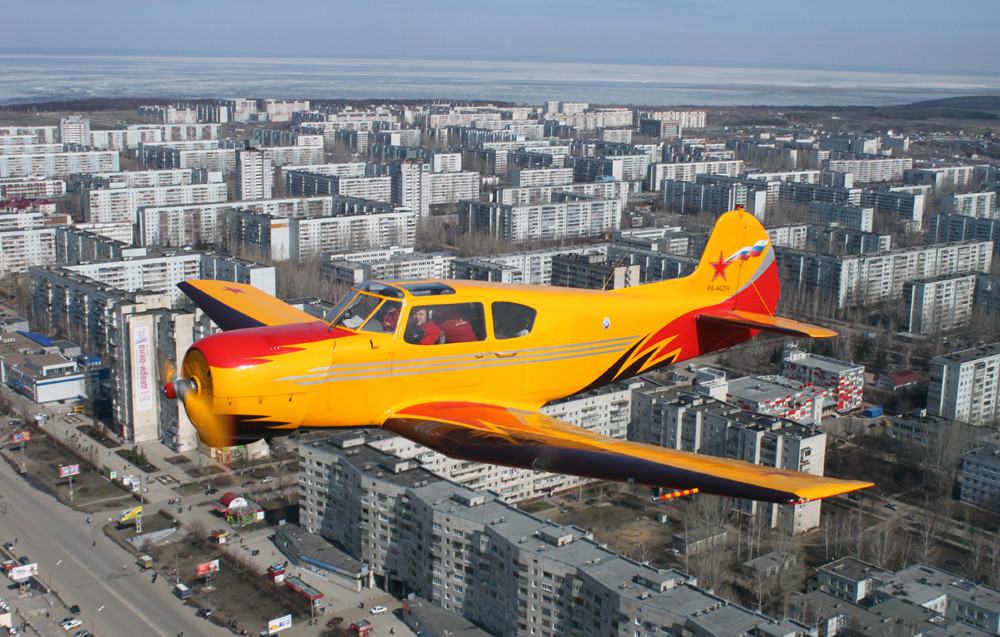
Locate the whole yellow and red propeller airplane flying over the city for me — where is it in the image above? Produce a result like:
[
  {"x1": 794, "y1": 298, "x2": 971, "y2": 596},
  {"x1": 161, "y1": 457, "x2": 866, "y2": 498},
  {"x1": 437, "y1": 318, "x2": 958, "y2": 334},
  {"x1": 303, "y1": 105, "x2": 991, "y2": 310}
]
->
[{"x1": 164, "y1": 209, "x2": 872, "y2": 504}]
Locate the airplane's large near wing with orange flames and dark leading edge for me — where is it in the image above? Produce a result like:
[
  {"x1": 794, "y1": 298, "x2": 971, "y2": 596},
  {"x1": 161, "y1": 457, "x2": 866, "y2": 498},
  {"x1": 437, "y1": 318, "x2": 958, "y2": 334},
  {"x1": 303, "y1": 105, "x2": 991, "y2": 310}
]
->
[{"x1": 383, "y1": 402, "x2": 873, "y2": 504}]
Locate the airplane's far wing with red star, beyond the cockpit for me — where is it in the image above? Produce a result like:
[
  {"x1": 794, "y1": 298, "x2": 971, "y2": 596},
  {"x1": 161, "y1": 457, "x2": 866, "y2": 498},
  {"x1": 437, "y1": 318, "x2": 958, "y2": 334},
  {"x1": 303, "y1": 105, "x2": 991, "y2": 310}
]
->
[{"x1": 177, "y1": 279, "x2": 319, "y2": 331}]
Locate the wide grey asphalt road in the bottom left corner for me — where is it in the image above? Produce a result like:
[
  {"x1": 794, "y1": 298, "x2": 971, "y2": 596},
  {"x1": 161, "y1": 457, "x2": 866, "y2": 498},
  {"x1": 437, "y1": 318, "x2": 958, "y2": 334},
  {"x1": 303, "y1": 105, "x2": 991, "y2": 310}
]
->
[{"x1": 0, "y1": 448, "x2": 232, "y2": 637}]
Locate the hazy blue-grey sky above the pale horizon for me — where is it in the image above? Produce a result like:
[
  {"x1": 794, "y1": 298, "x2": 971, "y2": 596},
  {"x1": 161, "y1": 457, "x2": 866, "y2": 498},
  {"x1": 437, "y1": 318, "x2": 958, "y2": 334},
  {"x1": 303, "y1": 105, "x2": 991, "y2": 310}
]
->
[{"x1": 0, "y1": 0, "x2": 1000, "y2": 76}]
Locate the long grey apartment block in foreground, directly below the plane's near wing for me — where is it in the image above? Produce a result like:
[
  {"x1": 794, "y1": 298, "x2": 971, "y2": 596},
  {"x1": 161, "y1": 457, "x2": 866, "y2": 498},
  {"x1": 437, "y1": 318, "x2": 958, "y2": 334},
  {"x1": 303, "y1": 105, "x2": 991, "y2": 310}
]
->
[{"x1": 299, "y1": 434, "x2": 797, "y2": 637}]
